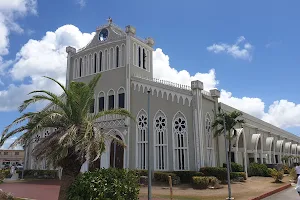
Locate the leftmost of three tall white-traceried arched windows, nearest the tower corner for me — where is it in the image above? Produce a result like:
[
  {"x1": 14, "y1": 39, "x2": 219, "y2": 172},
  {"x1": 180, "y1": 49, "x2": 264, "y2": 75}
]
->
[{"x1": 137, "y1": 110, "x2": 148, "y2": 169}]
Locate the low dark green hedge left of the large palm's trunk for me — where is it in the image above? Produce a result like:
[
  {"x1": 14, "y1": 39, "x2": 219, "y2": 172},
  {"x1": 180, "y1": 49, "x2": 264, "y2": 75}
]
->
[{"x1": 17, "y1": 170, "x2": 58, "y2": 179}]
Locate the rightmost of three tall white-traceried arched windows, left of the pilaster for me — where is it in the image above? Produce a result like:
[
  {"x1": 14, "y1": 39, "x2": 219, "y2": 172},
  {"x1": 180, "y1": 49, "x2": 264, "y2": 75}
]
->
[{"x1": 173, "y1": 112, "x2": 188, "y2": 170}]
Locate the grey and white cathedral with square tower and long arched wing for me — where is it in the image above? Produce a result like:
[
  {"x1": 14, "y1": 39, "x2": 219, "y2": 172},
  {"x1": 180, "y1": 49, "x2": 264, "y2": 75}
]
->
[{"x1": 24, "y1": 19, "x2": 300, "y2": 174}]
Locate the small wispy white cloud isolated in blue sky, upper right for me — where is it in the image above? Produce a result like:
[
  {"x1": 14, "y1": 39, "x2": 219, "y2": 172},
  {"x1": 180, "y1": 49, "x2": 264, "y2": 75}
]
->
[{"x1": 207, "y1": 36, "x2": 253, "y2": 61}]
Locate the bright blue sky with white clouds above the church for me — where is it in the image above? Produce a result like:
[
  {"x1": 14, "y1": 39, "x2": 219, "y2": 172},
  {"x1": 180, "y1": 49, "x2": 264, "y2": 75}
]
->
[{"x1": 0, "y1": 0, "x2": 300, "y2": 148}]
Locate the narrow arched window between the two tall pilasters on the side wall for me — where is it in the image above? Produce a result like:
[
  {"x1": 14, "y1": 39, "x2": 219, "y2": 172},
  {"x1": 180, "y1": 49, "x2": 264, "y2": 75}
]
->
[{"x1": 205, "y1": 113, "x2": 214, "y2": 167}]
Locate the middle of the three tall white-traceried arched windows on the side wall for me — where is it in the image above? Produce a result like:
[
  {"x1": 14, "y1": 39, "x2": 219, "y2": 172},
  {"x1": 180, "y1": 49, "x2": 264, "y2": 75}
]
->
[{"x1": 153, "y1": 111, "x2": 168, "y2": 170}]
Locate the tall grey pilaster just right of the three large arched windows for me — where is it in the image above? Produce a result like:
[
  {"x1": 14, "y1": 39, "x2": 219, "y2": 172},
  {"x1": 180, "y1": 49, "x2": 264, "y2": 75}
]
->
[{"x1": 191, "y1": 80, "x2": 205, "y2": 170}]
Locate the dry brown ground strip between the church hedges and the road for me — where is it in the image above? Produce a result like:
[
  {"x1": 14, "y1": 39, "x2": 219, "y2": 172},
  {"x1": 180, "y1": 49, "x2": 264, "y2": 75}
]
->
[{"x1": 140, "y1": 176, "x2": 291, "y2": 200}]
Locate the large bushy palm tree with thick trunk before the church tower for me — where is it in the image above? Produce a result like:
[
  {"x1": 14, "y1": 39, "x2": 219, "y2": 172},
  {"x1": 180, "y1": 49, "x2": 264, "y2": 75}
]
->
[{"x1": 0, "y1": 75, "x2": 133, "y2": 200}]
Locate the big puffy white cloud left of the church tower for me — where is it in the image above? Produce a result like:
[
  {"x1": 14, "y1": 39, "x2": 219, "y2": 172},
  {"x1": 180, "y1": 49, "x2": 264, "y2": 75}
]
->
[{"x1": 0, "y1": 25, "x2": 95, "y2": 111}]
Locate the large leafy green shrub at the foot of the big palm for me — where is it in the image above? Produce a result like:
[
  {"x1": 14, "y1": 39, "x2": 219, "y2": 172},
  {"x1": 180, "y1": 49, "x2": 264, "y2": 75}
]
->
[{"x1": 68, "y1": 168, "x2": 139, "y2": 200}]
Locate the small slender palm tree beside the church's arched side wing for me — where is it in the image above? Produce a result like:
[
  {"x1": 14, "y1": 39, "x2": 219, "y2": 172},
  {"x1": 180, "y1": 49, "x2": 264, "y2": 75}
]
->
[{"x1": 212, "y1": 107, "x2": 245, "y2": 170}]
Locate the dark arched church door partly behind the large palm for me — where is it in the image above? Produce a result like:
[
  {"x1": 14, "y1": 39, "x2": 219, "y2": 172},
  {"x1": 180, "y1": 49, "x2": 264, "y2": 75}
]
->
[{"x1": 110, "y1": 136, "x2": 124, "y2": 169}]
